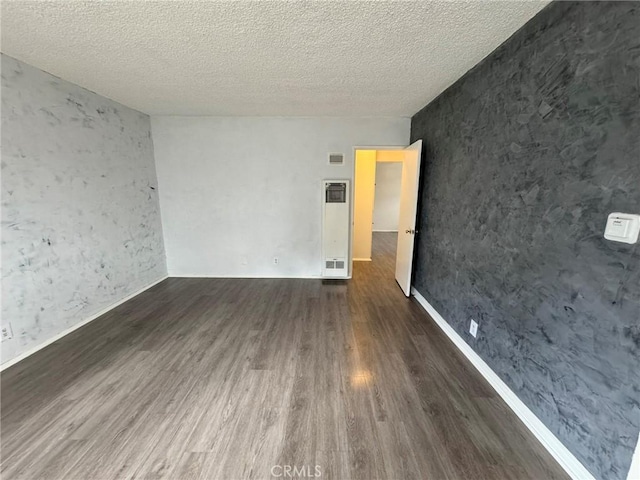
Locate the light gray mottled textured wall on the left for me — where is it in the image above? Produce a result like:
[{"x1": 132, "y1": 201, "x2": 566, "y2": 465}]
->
[{"x1": 2, "y1": 55, "x2": 166, "y2": 363}]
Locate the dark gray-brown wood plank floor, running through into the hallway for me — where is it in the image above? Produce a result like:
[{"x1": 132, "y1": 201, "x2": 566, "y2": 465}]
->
[{"x1": 1, "y1": 234, "x2": 566, "y2": 480}]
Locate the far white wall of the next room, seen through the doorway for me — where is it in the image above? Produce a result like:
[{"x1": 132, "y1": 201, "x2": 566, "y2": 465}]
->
[{"x1": 373, "y1": 162, "x2": 402, "y2": 232}]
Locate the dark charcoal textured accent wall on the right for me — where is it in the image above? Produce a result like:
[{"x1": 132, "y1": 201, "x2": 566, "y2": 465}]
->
[{"x1": 411, "y1": 2, "x2": 640, "y2": 479}]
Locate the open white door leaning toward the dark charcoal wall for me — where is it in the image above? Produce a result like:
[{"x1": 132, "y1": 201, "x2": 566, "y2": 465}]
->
[{"x1": 396, "y1": 140, "x2": 422, "y2": 297}]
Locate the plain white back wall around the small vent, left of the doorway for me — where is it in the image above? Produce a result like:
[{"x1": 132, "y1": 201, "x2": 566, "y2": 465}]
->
[{"x1": 151, "y1": 116, "x2": 410, "y2": 277}]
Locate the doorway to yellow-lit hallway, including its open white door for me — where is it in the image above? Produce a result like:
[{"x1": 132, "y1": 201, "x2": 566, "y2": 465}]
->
[{"x1": 351, "y1": 141, "x2": 422, "y2": 296}]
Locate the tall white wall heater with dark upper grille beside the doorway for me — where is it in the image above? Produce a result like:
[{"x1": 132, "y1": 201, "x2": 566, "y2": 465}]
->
[{"x1": 322, "y1": 180, "x2": 351, "y2": 278}]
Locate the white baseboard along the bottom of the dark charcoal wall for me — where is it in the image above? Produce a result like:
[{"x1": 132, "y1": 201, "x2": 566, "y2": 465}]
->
[{"x1": 411, "y1": 287, "x2": 594, "y2": 480}]
